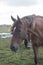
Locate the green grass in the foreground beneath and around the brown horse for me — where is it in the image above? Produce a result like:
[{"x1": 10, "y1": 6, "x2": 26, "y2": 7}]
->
[{"x1": 0, "y1": 38, "x2": 43, "y2": 65}]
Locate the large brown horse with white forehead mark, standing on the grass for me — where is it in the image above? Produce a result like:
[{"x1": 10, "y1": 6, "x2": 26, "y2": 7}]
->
[{"x1": 10, "y1": 15, "x2": 43, "y2": 65}]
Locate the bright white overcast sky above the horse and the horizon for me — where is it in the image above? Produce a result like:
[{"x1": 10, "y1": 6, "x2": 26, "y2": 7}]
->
[{"x1": 0, "y1": 0, "x2": 43, "y2": 24}]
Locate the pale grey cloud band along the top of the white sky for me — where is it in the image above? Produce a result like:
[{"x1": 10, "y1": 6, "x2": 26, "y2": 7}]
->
[{"x1": 0, "y1": 0, "x2": 37, "y2": 6}]
